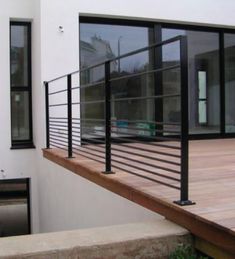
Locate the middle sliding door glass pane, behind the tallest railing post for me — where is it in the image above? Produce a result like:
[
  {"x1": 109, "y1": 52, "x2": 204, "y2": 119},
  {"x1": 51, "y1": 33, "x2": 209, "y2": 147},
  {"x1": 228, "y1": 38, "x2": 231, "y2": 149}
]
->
[{"x1": 162, "y1": 29, "x2": 220, "y2": 134}]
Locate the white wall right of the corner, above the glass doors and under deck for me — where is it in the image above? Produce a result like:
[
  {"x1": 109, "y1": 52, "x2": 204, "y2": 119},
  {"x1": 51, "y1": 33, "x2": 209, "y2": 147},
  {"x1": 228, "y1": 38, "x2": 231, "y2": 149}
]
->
[{"x1": 38, "y1": 0, "x2": 235, "y2": 231}]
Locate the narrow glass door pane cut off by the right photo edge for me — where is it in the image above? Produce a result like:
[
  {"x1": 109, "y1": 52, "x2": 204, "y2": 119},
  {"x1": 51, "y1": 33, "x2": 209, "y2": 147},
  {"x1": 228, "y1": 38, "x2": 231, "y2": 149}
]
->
[{"x1": 224, "y1": 34, "x2": 235, "y2": 132}]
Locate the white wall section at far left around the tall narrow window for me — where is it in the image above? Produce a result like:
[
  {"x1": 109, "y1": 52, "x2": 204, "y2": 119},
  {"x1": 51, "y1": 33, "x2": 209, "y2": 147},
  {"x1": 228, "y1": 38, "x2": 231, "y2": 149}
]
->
[{"x1": 0, "y1": 0, "x2": 39, "y2": 232}]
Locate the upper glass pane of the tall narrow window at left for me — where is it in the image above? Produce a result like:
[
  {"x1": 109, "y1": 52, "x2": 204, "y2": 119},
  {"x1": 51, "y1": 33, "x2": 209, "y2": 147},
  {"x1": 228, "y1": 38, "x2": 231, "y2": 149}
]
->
[{"x1": 11, "y1": 25, "x2": 29, "y2": 86}]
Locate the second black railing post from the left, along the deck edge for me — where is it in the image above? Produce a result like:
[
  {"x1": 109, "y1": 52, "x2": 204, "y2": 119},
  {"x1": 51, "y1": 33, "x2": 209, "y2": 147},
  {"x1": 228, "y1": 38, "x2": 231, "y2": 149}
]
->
[{"x1": 67, "y1": 74, "x2": 73, "y2": 158}]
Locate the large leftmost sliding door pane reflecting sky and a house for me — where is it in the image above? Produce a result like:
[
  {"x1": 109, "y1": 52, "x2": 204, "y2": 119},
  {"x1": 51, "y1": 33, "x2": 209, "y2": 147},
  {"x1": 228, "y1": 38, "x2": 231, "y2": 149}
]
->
[{"x1": 80, "y1": 23, "x2": 155, "y2": 137}]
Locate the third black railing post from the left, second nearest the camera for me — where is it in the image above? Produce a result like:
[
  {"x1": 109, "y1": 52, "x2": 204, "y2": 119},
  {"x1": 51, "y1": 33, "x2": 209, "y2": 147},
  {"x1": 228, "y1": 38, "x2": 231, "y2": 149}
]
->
[{"x1": 104, "y1": 61, "x2": 113, "y2": 174}]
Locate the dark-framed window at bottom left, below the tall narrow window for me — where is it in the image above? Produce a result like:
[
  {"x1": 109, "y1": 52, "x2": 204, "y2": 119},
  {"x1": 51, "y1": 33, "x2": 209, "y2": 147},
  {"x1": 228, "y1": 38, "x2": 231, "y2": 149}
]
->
[{"x1": 0, "y1": 179, "x2": 30, "y2": 237}]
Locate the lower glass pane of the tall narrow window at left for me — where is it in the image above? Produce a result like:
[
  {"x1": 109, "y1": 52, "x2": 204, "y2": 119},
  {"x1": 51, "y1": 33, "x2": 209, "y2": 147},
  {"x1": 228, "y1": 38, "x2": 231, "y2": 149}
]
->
[{"x1": 11, "y1": 91, "x2": 30, "y2": 141}]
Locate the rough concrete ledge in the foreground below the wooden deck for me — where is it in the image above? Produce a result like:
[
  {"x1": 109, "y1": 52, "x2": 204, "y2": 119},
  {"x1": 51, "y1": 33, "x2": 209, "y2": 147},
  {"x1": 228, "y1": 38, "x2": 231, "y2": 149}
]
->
[{"x1": 0, "y1": 219, "x2": 192, "y2": 259}]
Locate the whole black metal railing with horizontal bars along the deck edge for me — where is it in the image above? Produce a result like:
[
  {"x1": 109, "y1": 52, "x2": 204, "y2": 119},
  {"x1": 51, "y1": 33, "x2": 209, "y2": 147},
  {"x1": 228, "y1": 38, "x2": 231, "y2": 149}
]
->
[{"x1": 44, "y1": 36, "x2": 193, "y2": 205}]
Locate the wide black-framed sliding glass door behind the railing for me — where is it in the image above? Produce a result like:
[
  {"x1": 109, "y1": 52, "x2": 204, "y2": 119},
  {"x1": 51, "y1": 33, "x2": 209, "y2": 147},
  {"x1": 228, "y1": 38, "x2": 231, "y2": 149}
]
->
[{"x1": 80, "y1": 18, "x2": 235, "y2": 138}]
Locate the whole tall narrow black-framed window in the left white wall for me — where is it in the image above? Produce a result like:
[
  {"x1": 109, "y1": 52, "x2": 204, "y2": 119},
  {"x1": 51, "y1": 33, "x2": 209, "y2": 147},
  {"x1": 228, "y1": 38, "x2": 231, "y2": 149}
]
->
[{"x1": 10, "y1": 22, "x2": 34, "y2": 148}]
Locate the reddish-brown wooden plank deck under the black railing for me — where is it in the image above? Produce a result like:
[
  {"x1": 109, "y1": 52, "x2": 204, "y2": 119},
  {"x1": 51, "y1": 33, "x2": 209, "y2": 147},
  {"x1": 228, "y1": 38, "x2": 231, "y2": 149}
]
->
[{"x1": 43, "y1": 139, "x2": 235, "y2": 258}]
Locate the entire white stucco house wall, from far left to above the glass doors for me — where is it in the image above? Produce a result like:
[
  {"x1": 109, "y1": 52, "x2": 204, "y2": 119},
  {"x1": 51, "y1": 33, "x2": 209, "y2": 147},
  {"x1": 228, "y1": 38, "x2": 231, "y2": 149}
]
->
[{"x1": 0, "y1": 0, "x2": 235, "y2": 235}]
